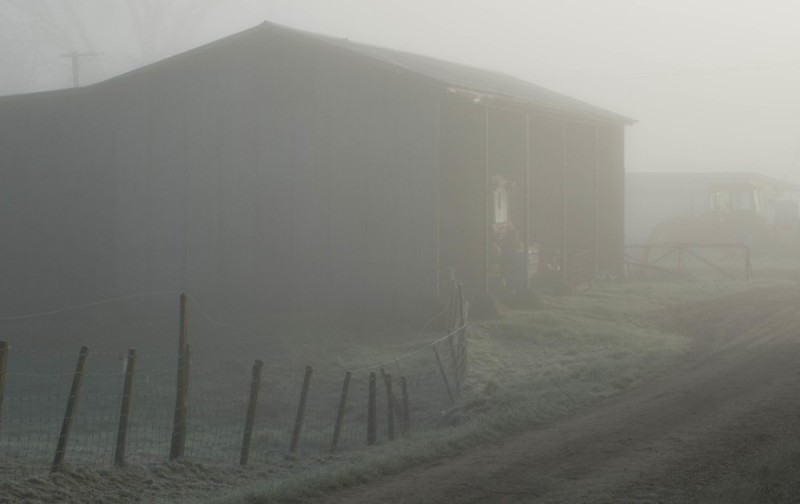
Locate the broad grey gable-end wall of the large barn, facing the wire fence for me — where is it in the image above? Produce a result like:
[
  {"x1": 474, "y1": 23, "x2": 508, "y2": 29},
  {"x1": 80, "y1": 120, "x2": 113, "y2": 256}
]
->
[{"x1": 0, "y1": 27, "x2": 439, "y2": 313}]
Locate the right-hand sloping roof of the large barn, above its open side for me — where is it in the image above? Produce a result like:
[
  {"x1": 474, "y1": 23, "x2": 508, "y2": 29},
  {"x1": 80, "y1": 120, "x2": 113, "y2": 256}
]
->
[{"x1": 266, "y1": 22, "x2": 636, "y2": 124}]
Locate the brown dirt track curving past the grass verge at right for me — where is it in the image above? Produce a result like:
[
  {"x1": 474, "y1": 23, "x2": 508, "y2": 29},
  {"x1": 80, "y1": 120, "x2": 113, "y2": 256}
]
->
[{"x1": 309, "y1": 288, "x2": 800, "y2": 504}]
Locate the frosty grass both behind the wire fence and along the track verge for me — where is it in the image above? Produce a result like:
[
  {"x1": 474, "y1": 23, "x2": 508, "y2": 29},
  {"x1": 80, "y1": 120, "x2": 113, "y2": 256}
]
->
[{"x1": 0, "y1": 280, "x2": 797, "y2": 504}]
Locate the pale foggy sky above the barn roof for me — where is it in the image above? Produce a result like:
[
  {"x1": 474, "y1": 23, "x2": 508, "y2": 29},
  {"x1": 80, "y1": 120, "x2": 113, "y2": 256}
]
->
[{"x1": 0, "y1": 0, "x2": 800, "y2": 182}]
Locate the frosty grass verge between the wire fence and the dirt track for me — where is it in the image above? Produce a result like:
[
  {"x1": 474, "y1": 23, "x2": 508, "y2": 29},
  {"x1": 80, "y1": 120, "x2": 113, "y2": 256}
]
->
[{"x1": 192, "y1": 280, "x2": 788, "y2": 504}]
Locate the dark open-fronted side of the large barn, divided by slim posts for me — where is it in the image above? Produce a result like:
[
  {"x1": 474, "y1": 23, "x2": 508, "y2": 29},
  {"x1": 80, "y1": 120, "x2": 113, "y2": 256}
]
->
[{"x1": 440, "y1": 91, "x2": 625, "y2": 300}]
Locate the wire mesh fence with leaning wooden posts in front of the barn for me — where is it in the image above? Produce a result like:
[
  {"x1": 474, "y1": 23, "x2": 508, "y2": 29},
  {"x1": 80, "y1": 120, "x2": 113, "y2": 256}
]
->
[{"x1": 0, "y1": 290, "x2": 466, "y2": 470}]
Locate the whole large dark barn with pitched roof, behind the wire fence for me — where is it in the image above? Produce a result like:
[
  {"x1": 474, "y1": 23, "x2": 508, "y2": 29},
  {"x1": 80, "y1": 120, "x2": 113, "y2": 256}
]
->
[{"x1": 0, "y1": 24, "x2": 631, "y2": 314}]
